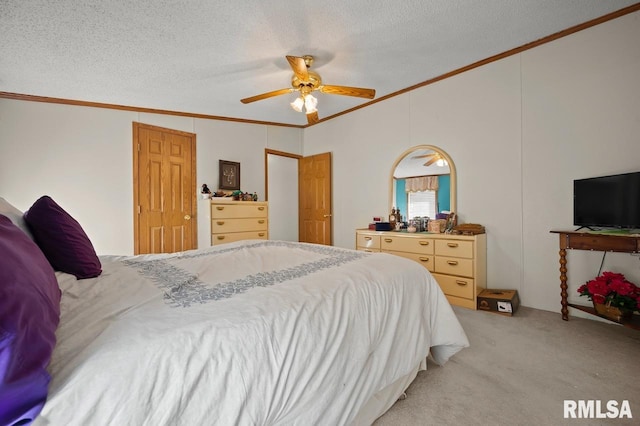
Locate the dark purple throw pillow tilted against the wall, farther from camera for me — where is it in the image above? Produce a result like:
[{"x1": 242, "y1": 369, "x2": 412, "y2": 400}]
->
[{"x1": 24, "y1": 195, "x2": 102, "y2": 280}]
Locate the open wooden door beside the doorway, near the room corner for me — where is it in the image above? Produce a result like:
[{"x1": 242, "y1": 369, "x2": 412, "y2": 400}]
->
[{"x1": 298, "y1": 152, "x2": 332, "y2": 245}]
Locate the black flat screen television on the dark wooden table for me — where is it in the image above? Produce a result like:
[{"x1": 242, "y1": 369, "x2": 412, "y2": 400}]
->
[{"x1": 573, "y1": 172, "x2": 640, "y2": 229}]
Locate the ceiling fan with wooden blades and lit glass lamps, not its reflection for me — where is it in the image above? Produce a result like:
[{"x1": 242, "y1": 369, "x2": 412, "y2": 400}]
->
[{"x1": 240, "y1": 55, "x2": 376, "y2": 124}]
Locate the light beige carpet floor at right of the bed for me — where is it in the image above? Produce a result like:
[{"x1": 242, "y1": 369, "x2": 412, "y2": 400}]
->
[{"x1": 375, "y1": 307, "x2": 640, "y2": 426}]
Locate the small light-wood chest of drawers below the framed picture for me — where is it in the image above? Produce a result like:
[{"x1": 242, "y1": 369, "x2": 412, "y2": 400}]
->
[{"x1": 211, "y1": 199, "x2": 269, "y2": 246}]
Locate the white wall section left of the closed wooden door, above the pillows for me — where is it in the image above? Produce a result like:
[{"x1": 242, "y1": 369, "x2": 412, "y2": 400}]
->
[{"x1": 0, "y1": 99, "x2": 138, "y2": 254}]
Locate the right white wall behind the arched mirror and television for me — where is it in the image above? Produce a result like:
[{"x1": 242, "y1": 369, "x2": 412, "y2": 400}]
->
[{"x1": 304, "y1": 12, "x2": 640, "y2": 311}]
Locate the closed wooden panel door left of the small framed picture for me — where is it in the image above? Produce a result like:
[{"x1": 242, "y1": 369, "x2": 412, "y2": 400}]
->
[{"x1": 133, "y1": 123, "x2": 197, "y2": 254}]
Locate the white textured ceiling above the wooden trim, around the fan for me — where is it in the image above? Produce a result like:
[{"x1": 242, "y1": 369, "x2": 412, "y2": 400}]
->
[{"x1": 0, "y1": 0, "x2": 637, "y2": 125}]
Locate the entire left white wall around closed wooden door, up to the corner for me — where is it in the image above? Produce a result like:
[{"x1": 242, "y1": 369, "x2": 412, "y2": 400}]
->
[{"x1": 0, "y1": 99, "x2": 302, "y2": 254}]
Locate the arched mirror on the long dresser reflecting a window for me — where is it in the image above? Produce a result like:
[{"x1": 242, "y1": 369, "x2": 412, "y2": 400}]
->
[{"x1": 389, "y1": 145, "x2": 457, "y2": 220}]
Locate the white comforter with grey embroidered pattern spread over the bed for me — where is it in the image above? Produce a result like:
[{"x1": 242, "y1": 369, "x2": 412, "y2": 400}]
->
[{"x1": 35, "y1": 241, "x2": 468, "y2": 426}]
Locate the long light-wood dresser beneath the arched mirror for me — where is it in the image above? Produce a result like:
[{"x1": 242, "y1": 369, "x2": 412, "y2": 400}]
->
[{"x1": 356, "y1": 229, "x2": 487, "y2": 309}]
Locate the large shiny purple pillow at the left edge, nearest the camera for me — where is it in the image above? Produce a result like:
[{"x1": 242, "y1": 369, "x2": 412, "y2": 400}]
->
[{"x1": 0, "y1": 215, "x2": 60, "y2": 425}]
